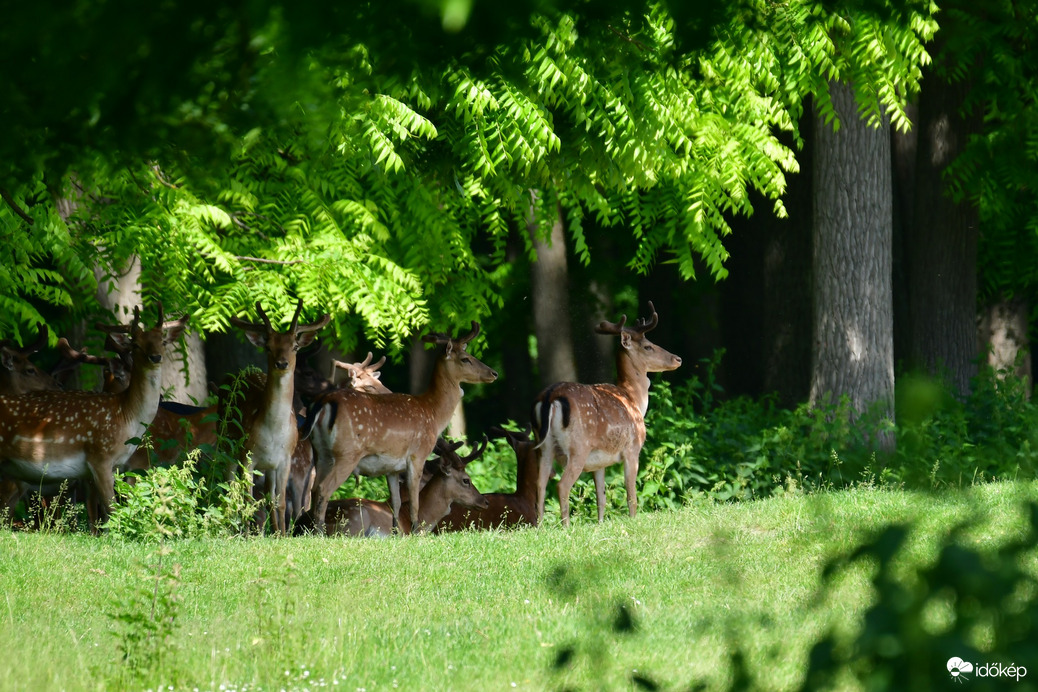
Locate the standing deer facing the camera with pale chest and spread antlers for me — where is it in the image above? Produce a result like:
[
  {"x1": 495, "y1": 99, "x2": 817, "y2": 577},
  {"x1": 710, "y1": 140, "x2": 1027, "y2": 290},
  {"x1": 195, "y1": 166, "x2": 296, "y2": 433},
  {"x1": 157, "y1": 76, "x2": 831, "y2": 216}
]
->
[{"x1": 221, "y1": 300, "x2": 331, "y2": 535}]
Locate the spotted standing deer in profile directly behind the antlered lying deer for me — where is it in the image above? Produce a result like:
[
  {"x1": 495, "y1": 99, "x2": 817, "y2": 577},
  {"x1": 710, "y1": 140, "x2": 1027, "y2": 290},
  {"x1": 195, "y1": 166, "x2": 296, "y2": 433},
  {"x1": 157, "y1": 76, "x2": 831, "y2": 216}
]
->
[{"x1": 310, "y1": 322, "x2": 497, "y2": 527}]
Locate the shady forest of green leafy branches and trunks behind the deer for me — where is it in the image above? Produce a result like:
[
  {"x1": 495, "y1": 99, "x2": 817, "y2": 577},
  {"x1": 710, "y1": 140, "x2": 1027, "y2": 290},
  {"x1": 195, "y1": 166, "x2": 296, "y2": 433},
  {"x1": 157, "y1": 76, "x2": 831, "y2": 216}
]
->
[{"x1": 0, "y1": 0, "x2": 1038, "y2": 496}]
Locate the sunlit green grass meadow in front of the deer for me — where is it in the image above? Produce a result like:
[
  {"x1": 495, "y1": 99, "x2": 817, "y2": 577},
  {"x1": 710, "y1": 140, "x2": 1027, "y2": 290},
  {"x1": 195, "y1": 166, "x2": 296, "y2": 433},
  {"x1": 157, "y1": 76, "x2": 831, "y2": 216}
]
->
[{"x1": 0, "y1": 482, "x2": 1038, "y2": 691}]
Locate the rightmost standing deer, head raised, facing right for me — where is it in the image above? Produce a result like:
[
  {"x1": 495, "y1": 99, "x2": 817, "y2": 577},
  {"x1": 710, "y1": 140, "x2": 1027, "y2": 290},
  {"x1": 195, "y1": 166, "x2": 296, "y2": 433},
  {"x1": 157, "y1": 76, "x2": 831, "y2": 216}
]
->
[{"x1": 532, "y1": 301, "x2": 681, "y2": 526}]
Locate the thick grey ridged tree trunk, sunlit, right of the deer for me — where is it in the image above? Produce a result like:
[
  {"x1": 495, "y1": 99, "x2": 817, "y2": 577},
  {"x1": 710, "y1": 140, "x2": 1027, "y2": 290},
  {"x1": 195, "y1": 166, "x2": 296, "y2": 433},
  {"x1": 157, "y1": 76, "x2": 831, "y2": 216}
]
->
[{"x1": 811, "y1": 83, "x2": 894, "y2": 433}]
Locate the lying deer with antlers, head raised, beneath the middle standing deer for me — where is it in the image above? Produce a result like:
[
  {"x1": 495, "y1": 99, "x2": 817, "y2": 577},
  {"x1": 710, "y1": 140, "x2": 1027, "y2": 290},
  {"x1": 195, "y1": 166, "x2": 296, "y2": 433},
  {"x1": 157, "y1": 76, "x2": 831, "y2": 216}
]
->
[{"x1": 325, "y1": 441, "x2": 487, "y2": 536}]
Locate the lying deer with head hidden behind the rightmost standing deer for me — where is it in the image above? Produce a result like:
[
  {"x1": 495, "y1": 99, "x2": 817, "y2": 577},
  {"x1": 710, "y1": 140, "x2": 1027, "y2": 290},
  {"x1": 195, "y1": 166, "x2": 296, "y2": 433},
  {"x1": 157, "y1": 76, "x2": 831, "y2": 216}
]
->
[{"x1": 437, "y1": 427, "x2": 541, "y2": 532}]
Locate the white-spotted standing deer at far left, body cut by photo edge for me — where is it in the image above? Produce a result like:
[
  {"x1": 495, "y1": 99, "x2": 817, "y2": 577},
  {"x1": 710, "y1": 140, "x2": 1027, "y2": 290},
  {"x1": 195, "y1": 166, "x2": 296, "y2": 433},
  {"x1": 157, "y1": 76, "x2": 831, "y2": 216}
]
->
[{"x1": 0, "y1": 304, "x2": 188, "y2": 532}]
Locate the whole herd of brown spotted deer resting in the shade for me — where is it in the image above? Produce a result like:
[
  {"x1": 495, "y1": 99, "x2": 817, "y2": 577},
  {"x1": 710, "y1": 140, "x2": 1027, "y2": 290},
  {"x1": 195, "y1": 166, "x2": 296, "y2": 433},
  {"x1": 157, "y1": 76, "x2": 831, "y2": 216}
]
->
[{"x1": 0, "y1": 301, "x2": 681, "y2": 535}]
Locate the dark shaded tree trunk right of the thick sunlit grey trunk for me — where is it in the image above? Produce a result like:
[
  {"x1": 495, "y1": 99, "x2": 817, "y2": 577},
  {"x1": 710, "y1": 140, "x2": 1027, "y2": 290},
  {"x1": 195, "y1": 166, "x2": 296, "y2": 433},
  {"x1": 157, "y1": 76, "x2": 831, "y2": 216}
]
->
[{"x1": 905, "y1": 45, "x2": 978, "y2": 394}]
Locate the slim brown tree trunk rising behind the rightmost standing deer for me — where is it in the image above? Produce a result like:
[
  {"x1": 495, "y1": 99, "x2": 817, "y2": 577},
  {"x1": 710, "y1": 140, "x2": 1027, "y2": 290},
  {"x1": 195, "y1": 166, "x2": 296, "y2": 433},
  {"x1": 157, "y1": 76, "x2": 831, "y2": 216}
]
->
[{"x1": 528, "y1": 197, "x2": 577, "y2": 387}]
